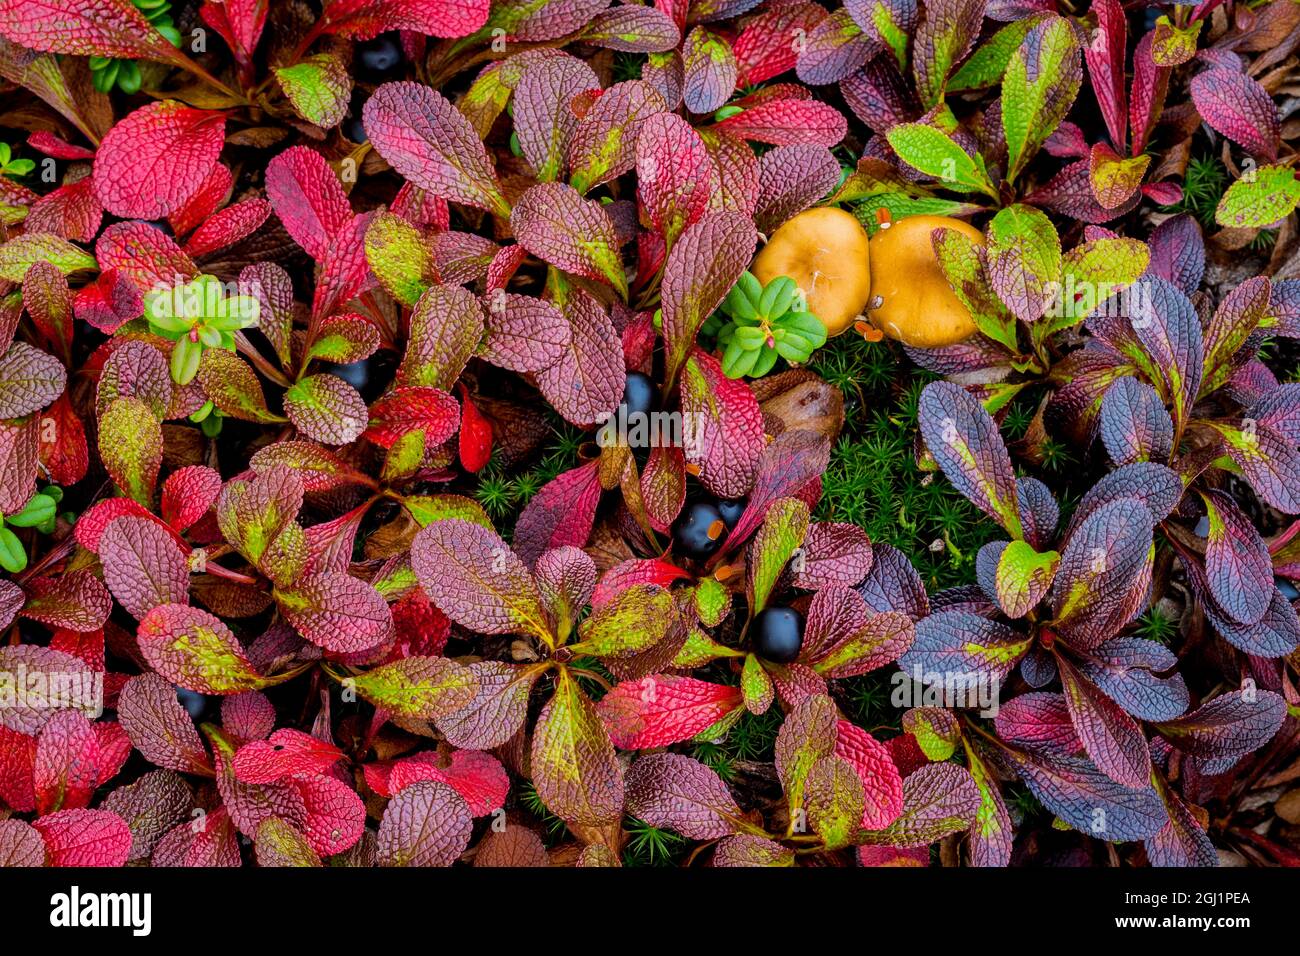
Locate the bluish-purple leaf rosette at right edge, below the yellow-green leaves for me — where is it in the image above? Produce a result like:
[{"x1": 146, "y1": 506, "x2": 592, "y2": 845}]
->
[{"x1": 1048, "y1": 252, "x2": 1300, "y2": 514}]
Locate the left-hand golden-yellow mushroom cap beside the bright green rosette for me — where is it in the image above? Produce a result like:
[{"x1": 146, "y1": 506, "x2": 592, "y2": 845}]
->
[{"x1": 750, "y1": 207, "x2": 871, "y2": 336}]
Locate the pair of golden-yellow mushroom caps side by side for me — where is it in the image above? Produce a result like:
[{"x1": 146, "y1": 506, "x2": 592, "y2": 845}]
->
[{"x1": 753, "y1": 207, "x2": 984, "y2": 349}]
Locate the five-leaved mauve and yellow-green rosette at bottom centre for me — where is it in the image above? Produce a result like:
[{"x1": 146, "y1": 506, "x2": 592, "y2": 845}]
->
[{"x1": 411, "y1": 518, "x2": 688, "y2": 851}]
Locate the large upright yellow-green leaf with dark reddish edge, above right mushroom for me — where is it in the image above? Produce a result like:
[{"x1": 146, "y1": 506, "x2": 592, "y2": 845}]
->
[{"x1": 1002, "y1": 17, "x2": 1083, "y2": 181}]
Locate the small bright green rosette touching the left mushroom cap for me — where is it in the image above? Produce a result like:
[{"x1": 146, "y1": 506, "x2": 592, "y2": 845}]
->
[{"x1": 701, "y1": 271, "x2": 826, "y2": 378}]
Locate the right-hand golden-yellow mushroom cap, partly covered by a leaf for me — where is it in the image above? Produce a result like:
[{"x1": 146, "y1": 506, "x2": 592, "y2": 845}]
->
[{"x1": 867, "y1": 216, "x2": 984, "y2": 349}]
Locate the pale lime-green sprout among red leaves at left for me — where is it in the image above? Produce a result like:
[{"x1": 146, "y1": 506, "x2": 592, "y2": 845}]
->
[{"x1": 144, "y1": 276, "x2": 259, "y2": 385}]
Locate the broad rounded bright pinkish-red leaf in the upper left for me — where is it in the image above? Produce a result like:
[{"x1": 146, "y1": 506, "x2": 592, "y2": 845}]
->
[{"x1": 94, "y1": 100, "x2": 226, "y2": 219}]
